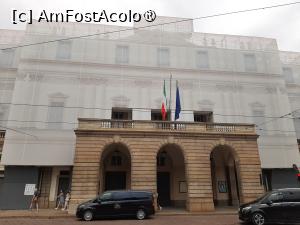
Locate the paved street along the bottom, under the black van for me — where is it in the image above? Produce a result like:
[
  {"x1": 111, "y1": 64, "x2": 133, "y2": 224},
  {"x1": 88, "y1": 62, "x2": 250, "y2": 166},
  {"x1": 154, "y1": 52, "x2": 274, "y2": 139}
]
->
[{"x1": 0, "y1": 215, "x2": 244, "y2": 225}]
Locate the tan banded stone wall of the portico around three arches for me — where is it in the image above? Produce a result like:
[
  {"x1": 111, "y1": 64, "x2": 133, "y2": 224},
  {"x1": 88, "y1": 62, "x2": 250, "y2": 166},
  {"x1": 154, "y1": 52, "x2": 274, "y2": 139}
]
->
[{"x1": 71, "y1": 123, "x2": 263, "y2": 211}]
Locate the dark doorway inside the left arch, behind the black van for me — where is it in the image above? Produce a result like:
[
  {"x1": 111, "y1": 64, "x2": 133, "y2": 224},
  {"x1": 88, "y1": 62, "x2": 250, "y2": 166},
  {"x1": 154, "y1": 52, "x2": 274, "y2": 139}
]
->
[{"x1": 105, "y1": 172, "x2": 126, "y2": 191}]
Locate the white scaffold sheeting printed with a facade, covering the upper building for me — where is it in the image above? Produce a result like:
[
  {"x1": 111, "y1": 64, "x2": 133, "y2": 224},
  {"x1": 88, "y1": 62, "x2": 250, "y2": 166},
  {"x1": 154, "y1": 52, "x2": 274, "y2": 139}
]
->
[{"x1": 0, "y1": 18, "x2": 300, "y2": 171}]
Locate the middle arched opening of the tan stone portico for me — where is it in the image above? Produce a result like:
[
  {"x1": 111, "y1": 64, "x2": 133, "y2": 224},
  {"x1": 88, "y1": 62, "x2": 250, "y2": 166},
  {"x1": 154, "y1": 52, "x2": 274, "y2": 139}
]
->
[{"x1": 156, "y1": 144, "x2": 187, "y2": 208}]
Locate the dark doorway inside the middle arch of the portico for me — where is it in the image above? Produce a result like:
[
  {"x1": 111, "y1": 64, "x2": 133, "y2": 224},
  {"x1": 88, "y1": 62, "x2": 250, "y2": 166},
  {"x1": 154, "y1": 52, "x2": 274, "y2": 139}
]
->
[{"x1": 157, "y1": 172, "x2": 171, "y2": 206}]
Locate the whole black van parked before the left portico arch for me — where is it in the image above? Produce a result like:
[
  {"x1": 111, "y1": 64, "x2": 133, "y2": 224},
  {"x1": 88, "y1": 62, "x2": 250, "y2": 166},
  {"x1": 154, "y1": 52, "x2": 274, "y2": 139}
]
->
[{"x1": 76, "y1": 190, "x2": 155, "y2": 221}]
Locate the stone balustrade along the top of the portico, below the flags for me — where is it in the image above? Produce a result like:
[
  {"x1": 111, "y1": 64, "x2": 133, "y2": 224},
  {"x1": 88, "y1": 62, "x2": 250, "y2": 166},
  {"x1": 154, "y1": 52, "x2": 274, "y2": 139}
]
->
[{"x1": 78, "y1": 118, "x2": 255, "y2": 134}]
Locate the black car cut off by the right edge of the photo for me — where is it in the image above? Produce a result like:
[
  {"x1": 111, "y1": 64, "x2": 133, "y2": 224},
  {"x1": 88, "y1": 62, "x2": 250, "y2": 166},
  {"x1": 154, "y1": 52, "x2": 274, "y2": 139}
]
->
[{"x1": 239, "y1": 188, "x2": 300, "y2": 225}]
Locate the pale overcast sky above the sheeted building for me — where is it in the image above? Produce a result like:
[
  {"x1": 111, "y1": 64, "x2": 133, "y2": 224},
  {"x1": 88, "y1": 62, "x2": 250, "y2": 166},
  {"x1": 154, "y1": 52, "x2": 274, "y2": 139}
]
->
[{"x1": 0, "y1": 0, "x2": 300, "y2": 52}]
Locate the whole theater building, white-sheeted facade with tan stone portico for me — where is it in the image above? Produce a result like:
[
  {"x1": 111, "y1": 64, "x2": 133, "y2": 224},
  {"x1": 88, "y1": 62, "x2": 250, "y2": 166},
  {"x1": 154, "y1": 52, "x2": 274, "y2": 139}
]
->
[{"x1": 0, "y1": 17, "x2": 300, "y2": 212}]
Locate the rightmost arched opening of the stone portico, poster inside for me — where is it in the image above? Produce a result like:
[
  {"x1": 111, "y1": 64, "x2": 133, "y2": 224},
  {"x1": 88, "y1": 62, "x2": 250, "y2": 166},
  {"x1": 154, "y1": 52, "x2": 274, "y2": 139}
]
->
[{"x1": 210, "y1": 145, "x2": 240, "y2": 207}]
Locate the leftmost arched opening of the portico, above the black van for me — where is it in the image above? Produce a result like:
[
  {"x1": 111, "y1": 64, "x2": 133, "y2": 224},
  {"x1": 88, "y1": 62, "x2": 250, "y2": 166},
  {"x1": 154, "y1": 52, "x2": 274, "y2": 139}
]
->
[{"x1": 99, "y1": 143, "x2": 131, "y2": 193}]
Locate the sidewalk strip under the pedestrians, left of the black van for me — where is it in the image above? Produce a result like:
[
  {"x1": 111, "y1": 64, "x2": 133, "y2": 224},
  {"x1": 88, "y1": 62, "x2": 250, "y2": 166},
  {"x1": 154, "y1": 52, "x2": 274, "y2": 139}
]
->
[{"x1": 0, "y1": 209, "x2": 74, "y2": 219}]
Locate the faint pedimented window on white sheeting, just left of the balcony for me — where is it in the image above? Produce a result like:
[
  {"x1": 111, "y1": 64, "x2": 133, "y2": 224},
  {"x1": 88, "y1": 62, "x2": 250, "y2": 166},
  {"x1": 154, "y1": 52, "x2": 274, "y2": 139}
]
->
[{"x1": 48, "y1": 101, "x2": 65, "y2": 129}]
